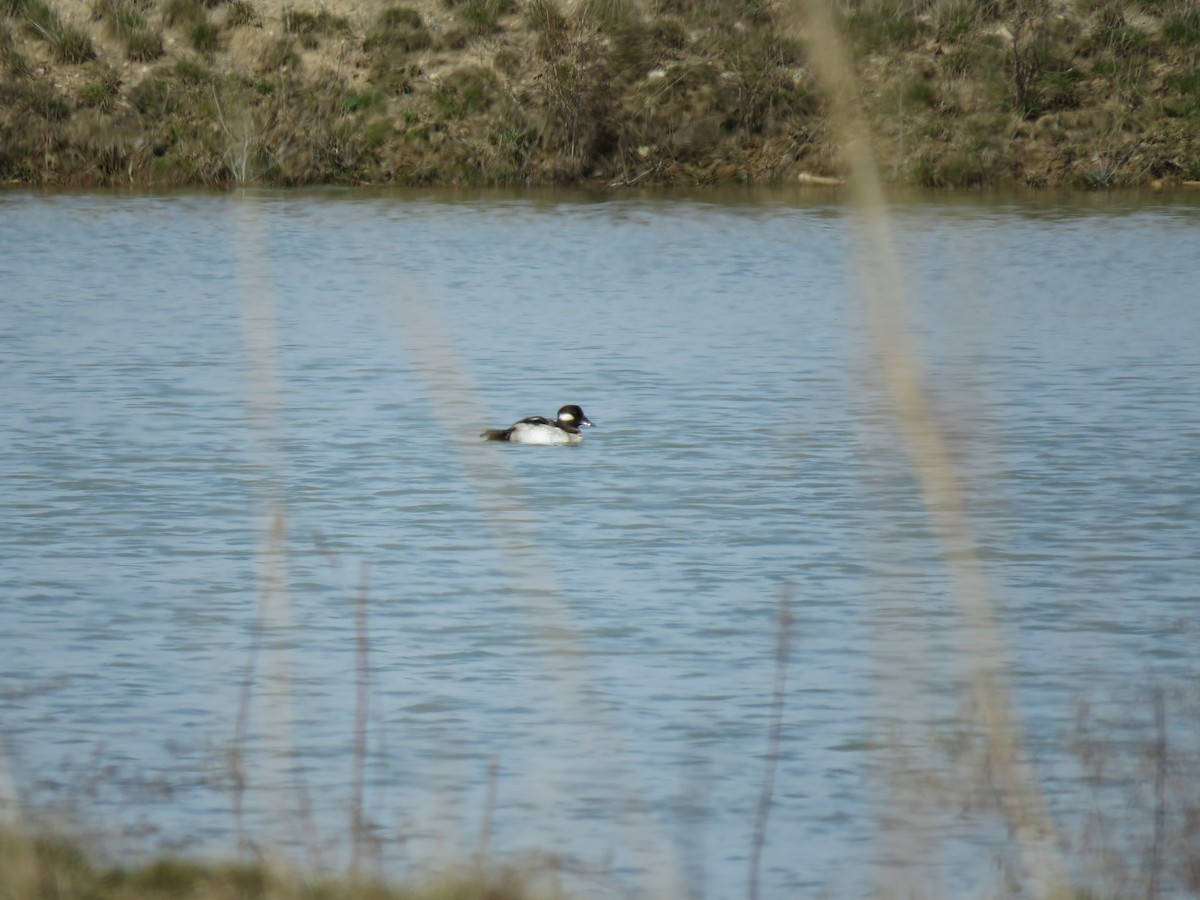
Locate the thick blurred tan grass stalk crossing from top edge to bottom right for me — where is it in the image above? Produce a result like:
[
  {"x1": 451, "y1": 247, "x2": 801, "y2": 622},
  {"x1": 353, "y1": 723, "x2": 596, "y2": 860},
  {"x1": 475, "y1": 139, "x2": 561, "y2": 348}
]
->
[{"x1": 788, "y1": 0, "x2": 1068, "y2": 896}]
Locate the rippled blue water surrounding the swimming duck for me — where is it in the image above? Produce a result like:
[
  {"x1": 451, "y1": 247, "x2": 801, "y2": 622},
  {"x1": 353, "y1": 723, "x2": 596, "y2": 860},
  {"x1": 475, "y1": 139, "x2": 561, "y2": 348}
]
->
[{"x1": 0, "y1": 192, "x2": 1200, "y2": 898}]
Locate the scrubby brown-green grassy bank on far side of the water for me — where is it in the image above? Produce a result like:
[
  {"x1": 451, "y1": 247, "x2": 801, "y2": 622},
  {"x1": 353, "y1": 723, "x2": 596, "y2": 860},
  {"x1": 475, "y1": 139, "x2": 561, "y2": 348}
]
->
[{"x1": 0, "y1": 0, "x2": 1200, "y2": 187}]
